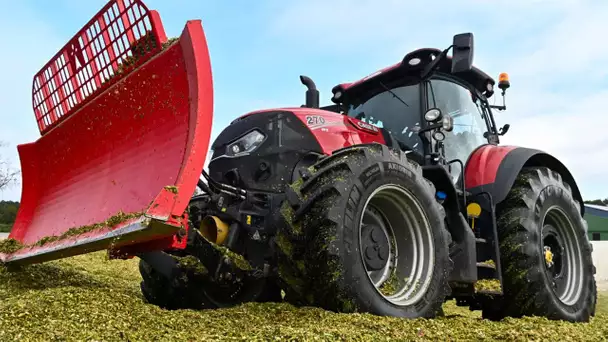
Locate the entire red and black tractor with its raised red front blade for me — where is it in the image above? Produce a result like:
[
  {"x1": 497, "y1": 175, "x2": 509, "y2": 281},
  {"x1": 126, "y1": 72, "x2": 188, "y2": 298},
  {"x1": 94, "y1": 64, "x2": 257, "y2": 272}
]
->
[{"x1": 2, "y1": 0, "x2": 596, "y2": 321}]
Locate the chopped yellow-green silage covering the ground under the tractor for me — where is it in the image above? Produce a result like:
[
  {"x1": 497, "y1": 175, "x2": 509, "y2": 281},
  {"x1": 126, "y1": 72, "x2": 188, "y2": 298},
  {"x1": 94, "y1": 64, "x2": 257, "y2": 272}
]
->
[{"x1": 0, "y1": 253, "x2": 608, "y2": 341}]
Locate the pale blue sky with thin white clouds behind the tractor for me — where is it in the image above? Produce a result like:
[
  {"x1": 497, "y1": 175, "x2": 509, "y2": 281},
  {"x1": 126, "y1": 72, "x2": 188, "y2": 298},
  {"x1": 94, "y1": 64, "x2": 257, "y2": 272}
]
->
[{"x1": 0, "y1": 0, "x2": 608, "y2": 200}]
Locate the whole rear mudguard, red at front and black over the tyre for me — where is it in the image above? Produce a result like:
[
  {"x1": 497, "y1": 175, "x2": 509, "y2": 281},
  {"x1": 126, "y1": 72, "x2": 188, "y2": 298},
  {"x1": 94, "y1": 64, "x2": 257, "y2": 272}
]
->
[{"x1": 465, "y1": 145, "x2": 585, "y2": 214}]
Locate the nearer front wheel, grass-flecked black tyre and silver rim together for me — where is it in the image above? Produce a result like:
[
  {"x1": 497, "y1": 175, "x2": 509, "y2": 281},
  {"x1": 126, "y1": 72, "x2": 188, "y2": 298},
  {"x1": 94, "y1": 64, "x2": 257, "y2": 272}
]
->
[{"x1": 276, "y1": 144, "x2": 453, "y2": 318}]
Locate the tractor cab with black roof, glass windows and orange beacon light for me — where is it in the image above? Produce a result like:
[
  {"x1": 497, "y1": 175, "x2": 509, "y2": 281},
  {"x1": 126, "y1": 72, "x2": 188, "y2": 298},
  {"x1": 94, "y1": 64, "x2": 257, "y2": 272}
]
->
[{"x1": 332, "y1": 33, "x2": 509, "y2": 181}]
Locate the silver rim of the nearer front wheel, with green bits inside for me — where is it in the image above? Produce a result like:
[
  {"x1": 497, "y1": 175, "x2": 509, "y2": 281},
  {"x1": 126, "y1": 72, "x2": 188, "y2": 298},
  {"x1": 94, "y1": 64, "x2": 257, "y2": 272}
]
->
[{"x1": 359, "y1": 185, "x2": 435, "y2": 306}]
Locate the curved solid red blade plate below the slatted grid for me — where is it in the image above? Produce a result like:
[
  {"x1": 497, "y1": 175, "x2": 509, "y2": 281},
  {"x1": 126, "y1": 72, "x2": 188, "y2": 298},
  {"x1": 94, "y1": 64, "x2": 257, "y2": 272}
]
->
[{"x1": 0, "y1": 6, "x2": 213, "y2": 259}]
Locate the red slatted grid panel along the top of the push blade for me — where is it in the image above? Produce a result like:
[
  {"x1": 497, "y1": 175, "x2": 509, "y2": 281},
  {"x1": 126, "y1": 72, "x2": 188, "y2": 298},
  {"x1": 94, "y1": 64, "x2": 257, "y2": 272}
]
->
[{"x1": 32, "y1": 0, "x2": 167, "y2": 134}]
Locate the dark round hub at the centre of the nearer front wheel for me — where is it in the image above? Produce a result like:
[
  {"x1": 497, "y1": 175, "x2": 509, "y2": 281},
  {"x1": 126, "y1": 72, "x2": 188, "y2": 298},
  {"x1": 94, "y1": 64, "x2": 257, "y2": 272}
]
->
[{"x1": 361, "y1": 224, "x2": 390, "y2": 271}]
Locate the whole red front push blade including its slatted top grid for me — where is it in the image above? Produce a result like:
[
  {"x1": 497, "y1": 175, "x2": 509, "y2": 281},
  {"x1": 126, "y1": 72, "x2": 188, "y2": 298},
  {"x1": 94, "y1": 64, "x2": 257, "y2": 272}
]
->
[{"x1": 0, "y1": 0, "x2": 213, "y2": 264}]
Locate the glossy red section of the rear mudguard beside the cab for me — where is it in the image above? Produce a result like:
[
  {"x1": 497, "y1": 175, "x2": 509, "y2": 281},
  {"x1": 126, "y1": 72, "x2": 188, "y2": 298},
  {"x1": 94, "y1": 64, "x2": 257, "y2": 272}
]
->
[{"x1": 465, "y1": 145, "x2": 517, "y2": 189}]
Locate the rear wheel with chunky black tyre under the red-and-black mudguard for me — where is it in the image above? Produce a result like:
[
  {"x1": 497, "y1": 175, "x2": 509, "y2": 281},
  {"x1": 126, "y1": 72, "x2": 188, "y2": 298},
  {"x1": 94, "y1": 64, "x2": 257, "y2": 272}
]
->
[{"x1": 482, "y1": 167, "x2": 597, "y2": 322}]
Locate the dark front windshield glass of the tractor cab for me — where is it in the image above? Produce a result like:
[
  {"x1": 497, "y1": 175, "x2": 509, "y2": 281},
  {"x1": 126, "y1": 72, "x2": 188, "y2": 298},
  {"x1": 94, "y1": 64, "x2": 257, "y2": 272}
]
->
[{"x1": 347, "y1": 84, "x2": 424, "y2": 154}]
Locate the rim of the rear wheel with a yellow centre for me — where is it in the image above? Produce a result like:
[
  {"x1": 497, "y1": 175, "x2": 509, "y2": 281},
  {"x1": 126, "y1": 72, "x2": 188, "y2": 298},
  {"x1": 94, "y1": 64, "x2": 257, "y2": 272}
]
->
[{"x1": 541, "y1": 206, "x2": 583, "y2": 305}]
